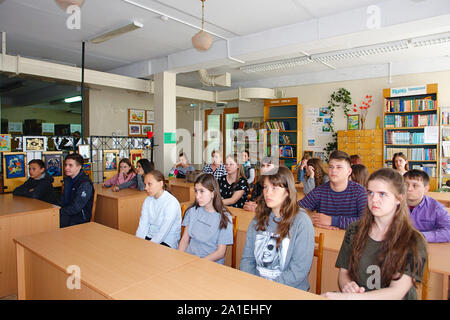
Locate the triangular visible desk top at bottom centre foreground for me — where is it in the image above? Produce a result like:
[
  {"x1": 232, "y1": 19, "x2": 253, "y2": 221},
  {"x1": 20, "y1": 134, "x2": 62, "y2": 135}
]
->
[{"x1": 113, "y1": 259, "x2": 325, "y2": 300}]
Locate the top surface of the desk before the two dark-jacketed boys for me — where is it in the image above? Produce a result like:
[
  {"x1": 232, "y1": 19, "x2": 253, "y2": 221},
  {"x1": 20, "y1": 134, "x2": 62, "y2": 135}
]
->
[{"x1": 0, "y1": 193, "x2": 60, "y2": 218}]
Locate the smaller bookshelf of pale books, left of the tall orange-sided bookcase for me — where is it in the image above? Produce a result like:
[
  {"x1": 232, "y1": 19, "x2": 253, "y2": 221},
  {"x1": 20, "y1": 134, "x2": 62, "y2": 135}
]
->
[{"x1": 233, "y1": 117, "x2": 264, "y2": 154}]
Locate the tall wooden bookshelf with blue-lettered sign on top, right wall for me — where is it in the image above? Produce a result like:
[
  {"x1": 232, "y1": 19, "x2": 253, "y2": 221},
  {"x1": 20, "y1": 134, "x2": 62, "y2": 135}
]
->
[{"x1": 383, "y1": 84, "x2": 440, "y2": 191}]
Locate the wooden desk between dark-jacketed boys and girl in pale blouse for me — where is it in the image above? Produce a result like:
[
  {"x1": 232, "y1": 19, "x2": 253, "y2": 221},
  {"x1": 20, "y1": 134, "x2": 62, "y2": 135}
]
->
[{"x1": 94, "y1": 184, "x2": 148, "y2": 235}]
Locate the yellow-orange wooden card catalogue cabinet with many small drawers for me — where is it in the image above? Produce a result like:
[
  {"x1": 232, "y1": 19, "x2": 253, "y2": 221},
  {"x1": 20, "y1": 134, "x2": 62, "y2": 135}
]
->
[{"x1": 338, "y1": 129, "x2": 383, "y2": 173}]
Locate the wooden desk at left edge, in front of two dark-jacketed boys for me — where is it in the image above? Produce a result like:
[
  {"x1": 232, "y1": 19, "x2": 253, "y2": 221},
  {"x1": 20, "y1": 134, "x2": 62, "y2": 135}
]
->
[{"x1": 0, "y1": 194, "x2": 59, "y2": 297}]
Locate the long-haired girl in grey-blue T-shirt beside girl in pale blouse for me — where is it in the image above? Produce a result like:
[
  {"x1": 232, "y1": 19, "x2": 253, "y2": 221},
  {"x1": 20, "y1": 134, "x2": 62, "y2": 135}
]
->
[{"x1": 178, "y1": 173, "x2": 233, "y2": 264}]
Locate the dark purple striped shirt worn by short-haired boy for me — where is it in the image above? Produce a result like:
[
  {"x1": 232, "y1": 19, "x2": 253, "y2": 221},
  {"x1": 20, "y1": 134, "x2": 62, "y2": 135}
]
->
[{"x1": 298, "y1": 181, "x2": 367, "y2": 229}]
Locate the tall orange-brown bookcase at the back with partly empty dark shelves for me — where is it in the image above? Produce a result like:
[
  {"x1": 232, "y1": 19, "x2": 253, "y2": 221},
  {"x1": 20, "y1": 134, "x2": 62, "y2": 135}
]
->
[{"x1": 263, "y1": 98, "x2": 303, "y2": 168}]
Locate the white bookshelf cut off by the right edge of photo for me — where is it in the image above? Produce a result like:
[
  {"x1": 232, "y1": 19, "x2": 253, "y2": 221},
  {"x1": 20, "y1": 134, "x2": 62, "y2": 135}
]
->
[{"x1": 439, "y1": 107, "x2": 450, "y2": 187}]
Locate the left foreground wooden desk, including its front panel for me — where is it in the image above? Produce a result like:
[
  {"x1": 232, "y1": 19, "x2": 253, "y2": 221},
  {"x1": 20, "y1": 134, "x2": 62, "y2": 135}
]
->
[{"x1": 15, "y1": 222, "x2": 200, "y2": 299}]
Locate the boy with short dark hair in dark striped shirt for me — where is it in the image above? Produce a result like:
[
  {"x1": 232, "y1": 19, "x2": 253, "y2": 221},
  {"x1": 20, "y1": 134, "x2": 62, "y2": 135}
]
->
[{"x1": 298, "y1": 150, "x2": 367, "y2": 229}]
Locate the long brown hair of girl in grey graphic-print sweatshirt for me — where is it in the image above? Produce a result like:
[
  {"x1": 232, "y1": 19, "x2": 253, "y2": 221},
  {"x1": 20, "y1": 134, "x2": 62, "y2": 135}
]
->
[{"x1": 255, "y1": 166, "x2": 299, "y2": 247}]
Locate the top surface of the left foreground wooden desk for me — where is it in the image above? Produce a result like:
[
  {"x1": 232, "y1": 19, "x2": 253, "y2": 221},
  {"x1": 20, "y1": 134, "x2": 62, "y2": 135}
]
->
[{"x1": 15, "y1": 222, "x2": 200, "y2": 296}]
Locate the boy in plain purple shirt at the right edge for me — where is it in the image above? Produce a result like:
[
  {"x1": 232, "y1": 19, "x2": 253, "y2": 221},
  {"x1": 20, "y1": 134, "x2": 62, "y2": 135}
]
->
[{"x1": 403, "y1": 169, "x2": 450, "y2": 242}]
